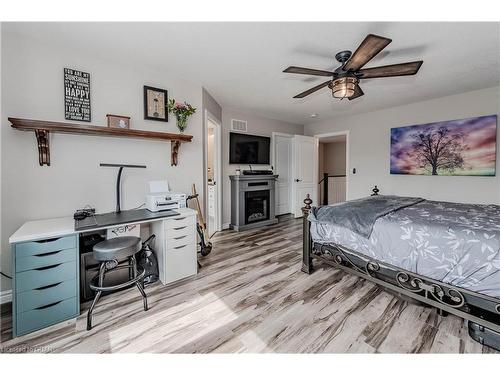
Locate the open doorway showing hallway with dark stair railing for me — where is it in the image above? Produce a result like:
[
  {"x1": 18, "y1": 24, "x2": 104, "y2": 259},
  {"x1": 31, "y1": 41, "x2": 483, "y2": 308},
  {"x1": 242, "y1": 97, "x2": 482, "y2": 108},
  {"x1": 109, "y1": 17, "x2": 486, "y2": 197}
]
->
[{"x1": 316, "y1": 132, "x2": 349, "y2": 205}]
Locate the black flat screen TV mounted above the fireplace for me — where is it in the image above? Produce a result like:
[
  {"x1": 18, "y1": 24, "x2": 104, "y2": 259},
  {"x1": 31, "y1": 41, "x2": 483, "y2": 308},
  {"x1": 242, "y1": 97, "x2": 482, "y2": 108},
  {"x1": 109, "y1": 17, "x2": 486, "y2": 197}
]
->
[{"x1": 229, "y1": 133, "x2": 271, "y2": 164}]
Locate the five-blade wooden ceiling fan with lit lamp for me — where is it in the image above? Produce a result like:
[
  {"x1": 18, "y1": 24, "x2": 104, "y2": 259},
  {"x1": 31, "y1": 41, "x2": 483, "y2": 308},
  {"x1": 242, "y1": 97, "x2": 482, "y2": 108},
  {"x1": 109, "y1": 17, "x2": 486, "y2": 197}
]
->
[{"x1": 283, "y1": 34, "x2": 423, "y2": 100}]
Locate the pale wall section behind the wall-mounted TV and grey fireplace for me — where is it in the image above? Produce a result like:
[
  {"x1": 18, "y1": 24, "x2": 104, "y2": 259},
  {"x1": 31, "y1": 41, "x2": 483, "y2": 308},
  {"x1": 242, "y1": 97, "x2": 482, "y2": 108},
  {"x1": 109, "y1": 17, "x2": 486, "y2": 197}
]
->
[{"x1": 222, "y1": 107, "x2": 304, "y2": 226}]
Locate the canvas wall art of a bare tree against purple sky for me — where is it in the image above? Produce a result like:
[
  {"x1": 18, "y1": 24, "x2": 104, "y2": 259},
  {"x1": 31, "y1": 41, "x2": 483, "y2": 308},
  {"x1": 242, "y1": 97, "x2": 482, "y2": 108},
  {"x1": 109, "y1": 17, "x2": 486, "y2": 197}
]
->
[{"x1": 391, "y1": 115, "x2": 497, "y2": 176}]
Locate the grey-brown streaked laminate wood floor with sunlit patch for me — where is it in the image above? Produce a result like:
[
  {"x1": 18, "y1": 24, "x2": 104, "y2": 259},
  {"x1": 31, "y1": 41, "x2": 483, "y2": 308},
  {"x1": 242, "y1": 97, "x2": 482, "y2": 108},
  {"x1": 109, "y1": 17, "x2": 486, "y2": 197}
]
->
[{"x1": 1, "y1": 217, "x2": 495, "y2": 353}]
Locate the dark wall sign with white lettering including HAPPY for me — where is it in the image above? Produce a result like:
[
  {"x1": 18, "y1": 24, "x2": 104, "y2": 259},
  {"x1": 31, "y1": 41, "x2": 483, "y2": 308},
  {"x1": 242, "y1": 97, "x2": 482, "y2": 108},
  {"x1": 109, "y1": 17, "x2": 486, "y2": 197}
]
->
[{"x1": 64, "y1": 68, "x2": 91, "y2": 122}]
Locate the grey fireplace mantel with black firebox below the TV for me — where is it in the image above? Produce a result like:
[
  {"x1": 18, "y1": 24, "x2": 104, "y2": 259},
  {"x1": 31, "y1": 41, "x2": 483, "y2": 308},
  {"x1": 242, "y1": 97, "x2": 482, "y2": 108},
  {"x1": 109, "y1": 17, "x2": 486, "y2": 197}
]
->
[{"x1": 229, "y1": 175, "x2": 278, "y2": 231}]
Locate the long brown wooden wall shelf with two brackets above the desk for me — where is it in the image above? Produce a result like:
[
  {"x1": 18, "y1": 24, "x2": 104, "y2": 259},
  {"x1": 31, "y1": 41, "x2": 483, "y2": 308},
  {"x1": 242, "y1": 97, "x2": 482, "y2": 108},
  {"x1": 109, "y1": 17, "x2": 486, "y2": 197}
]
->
[{"x1": 8, "y1": 117, "x2": 193, "y2": 165}]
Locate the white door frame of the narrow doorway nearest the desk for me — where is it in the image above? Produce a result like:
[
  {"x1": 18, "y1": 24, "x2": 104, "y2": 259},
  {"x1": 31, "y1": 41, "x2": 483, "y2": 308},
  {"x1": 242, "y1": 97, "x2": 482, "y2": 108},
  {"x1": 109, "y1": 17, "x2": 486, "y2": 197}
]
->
[{"x1": 203, "y1": 109, "x2": 222, "y2": 232}]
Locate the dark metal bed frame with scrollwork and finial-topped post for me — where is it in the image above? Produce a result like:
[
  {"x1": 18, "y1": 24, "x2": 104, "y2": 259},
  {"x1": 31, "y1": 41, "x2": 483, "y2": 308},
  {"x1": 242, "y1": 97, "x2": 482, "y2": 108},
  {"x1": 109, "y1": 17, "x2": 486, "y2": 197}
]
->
[{"x1": 302, "y1": 194, "x2": 500, "y2": 350}]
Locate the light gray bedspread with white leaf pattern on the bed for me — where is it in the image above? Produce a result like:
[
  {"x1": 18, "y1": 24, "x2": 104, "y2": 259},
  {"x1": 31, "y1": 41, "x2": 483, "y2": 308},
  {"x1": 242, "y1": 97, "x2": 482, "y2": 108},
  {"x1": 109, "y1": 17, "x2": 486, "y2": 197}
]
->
[{"x1": 311, "y1": 200, "x2": 500, "y2": 298}]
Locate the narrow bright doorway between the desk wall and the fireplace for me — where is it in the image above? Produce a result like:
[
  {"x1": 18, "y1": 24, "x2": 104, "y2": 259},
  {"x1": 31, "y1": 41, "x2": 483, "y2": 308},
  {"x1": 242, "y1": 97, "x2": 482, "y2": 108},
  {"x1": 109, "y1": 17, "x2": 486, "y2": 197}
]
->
[{"x1": 205, "y1": 111, "x2": 222, "y2": 237}]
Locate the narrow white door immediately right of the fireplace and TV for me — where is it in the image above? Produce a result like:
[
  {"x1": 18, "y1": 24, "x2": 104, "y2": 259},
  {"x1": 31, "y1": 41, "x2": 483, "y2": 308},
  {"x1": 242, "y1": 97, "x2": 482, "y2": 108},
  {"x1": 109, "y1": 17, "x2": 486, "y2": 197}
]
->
[{"x1": 273, "y1": 133, "x2": 293, "y2": 215}]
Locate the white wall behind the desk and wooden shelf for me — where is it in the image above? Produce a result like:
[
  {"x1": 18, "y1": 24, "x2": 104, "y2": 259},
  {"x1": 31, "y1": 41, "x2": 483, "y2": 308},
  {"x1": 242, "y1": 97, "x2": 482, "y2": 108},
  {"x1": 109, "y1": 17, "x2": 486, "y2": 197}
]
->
[{"x1": 0, "y1": 29, "x2": 204, "y2": 290}]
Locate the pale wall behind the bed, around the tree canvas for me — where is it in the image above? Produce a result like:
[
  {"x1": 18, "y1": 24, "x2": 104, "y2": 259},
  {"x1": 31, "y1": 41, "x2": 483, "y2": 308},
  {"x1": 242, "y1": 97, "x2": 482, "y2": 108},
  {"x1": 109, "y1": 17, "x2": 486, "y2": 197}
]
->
[{"x1": 304, "y1": 87, "x2": 500, "y2": 203}]
